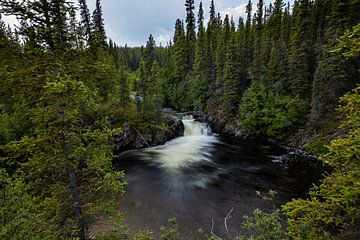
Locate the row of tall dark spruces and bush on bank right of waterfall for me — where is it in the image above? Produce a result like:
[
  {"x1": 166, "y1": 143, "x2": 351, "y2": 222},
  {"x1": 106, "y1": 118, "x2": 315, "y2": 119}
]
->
[{"x1": 131, "y1": 0, "x2": 360, "y2": 139}]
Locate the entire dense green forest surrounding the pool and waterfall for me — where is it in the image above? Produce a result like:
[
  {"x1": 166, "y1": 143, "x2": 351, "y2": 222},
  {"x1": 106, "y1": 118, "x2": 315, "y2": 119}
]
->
[{"x1": 0, "y1": 0, "x2": 360, "y2": 240}]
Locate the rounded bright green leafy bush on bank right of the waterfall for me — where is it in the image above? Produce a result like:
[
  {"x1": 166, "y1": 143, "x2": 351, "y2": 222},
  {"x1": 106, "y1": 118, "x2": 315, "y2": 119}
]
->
[{"x1": 239, "y1": 84, "x2": 307, "y2": 139}]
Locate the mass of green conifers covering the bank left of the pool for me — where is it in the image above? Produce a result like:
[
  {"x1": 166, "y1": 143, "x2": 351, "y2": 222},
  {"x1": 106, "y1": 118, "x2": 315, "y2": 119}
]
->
[{"x1": 0, "y1": 0, "x2": 158, "y2": 239}]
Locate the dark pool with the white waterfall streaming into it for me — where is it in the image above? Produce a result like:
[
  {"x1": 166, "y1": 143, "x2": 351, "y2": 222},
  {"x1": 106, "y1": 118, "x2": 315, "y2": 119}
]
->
[{"x1": 115, "y1": 117, "x2": 323, "y2": 239}]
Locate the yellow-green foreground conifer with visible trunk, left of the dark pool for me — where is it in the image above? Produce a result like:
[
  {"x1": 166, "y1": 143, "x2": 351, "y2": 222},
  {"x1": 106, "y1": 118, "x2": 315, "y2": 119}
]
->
[{"x1": 8, "y1": 75, "x2": 124, "y2": 240}]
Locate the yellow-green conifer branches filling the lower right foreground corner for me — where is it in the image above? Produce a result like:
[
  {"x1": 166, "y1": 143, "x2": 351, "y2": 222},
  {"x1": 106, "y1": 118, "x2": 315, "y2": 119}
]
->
[{"x1": 284, "y1": 87, "x2": 360, "y2": 239}]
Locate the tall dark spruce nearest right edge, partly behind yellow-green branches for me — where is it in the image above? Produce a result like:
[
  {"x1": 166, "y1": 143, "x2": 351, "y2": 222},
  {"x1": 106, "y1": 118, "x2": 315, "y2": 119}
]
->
[{"x1": 309, "y1": 1, "x2": 360, "y2": 130}]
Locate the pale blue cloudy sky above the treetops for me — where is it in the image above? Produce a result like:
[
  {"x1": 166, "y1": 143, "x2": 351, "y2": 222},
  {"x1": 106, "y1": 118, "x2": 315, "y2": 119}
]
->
[{"x1": 5, "y1": 0, "x2": 290, "y2": 46}]
